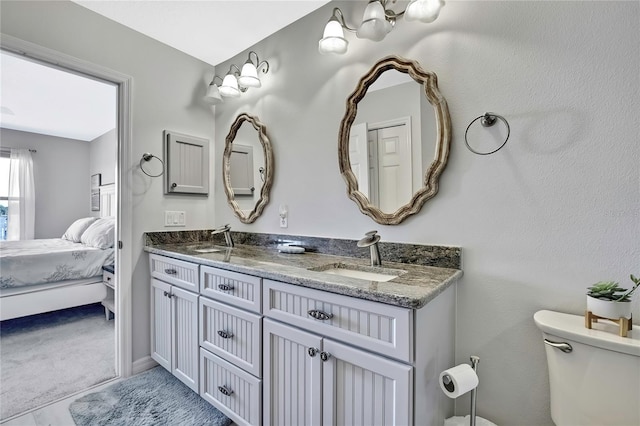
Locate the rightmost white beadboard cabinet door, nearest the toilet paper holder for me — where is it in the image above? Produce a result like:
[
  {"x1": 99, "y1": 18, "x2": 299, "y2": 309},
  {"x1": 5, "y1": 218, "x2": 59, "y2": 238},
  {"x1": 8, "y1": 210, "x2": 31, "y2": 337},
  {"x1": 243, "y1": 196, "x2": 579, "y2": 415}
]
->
[{"x1": 322, "y1": 339, "x2": 413, "y2": 426}]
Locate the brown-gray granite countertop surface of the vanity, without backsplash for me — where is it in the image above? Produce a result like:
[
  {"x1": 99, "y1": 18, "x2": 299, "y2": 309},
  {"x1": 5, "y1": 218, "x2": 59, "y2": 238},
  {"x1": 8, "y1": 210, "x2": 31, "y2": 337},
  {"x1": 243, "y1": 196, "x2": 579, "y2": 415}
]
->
[{"x1": 144, "y1": 242, "x2": 462, "y2": 309}]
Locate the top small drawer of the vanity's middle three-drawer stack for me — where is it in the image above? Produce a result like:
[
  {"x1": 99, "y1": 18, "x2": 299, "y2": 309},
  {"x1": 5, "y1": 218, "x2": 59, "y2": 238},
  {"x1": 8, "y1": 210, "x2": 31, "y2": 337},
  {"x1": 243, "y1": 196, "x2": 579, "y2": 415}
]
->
[{"x1": 200, "y1": 266, "x2": 262, "y2": 313}]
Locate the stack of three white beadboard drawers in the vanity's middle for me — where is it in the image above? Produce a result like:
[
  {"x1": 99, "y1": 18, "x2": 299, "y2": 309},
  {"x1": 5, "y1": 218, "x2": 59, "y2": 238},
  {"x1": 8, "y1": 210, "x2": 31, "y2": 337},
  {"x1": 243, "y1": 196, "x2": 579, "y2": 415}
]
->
[{"x1": 200, "y1": 266, "x2": 262, "y2": 425}]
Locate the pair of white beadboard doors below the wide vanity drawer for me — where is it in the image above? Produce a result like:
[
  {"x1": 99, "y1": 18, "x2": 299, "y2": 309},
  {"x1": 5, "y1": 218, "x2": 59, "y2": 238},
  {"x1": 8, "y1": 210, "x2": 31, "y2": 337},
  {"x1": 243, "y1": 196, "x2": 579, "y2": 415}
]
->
[{"x1": 263, "y1": 319, "x2": 413, "y2": 426}]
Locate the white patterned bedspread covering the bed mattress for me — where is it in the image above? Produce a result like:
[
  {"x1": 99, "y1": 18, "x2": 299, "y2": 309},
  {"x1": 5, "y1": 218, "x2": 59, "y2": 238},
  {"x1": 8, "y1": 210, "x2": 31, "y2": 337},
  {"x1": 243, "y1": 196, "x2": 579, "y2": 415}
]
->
[{"x1": 0, "y1": 238, "x2": 114, "y2": 289}]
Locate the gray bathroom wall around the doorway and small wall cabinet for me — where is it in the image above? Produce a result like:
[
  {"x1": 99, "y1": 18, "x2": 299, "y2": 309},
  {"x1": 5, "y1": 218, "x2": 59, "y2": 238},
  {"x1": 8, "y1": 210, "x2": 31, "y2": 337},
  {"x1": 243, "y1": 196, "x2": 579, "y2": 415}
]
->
[{"x1": 0, "y1": 1, "x2": 219, "y2": 361}]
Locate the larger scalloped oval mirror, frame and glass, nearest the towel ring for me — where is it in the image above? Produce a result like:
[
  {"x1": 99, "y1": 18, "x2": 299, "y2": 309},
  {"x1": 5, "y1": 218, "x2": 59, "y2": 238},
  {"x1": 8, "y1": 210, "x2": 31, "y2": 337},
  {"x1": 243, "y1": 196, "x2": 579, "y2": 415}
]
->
[{"x1": 338, "y1": 56, "x2": 451, "y2": 225}]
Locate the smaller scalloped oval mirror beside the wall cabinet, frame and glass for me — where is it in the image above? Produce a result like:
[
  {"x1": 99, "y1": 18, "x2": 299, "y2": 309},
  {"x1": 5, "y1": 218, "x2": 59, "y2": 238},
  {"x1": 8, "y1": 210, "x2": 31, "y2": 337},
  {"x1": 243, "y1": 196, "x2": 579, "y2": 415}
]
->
[{"x1": 222, "y1": 113, "x2": 273, "y2": 223}]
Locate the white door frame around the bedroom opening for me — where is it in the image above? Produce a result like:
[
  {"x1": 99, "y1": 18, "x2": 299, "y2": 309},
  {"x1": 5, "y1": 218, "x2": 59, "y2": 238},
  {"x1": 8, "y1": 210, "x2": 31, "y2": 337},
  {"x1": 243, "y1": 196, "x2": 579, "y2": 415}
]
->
[{"x1": 0, "y1": 34, "x2": 133, "y2": 377}]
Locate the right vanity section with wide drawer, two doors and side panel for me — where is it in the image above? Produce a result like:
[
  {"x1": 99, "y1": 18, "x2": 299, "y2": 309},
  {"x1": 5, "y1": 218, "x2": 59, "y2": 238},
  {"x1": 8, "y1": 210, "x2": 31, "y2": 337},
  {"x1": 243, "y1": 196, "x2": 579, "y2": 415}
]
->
[{"x1": 263, "y1": 280, "x2": 454, "y2": 426}]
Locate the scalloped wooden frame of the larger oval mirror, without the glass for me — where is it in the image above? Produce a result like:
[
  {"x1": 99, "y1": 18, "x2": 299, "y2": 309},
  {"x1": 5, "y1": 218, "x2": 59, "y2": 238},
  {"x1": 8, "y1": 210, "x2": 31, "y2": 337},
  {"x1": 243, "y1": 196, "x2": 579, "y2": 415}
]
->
[{"x1": 338, "y1": 56, "x2": 451, "y2": 225}]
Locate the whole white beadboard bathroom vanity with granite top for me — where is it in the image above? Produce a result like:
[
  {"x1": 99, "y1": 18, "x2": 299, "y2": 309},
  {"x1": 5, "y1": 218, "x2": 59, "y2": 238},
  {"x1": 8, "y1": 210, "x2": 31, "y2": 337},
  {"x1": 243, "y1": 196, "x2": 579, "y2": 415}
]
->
[{"x1": 145, "y1": 238, "x2": 462, "y2": 425}]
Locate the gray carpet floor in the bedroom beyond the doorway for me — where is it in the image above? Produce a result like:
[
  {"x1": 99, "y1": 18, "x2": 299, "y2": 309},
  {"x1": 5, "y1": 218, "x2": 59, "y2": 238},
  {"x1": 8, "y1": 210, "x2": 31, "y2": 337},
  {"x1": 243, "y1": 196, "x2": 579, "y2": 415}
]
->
[{"x1": 0, "y1": 304, "x2": 115, "y2": 419}]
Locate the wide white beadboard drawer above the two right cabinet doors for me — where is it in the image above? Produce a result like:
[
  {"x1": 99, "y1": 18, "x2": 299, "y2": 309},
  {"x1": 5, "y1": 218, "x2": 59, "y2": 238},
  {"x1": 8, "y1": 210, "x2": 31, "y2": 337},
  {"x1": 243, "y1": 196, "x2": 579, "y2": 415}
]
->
[{"x1": 263, "y1": 280, "x2": 413, "y2": 363}]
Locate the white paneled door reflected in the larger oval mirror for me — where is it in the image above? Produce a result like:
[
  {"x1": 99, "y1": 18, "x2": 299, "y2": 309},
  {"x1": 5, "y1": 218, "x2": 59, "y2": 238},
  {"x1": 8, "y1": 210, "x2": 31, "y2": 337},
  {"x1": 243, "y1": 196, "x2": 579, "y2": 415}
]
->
[{"x1": 377, "y1": 125, "x2": 413, "y2": 213}]
